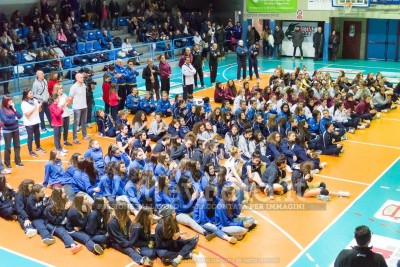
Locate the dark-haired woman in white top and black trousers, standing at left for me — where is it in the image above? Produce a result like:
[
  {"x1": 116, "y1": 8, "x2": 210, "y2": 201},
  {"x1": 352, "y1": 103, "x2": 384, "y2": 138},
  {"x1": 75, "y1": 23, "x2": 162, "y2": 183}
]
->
[{"x1": 21, "y1": 89, "x2": 46, "y2": 157}]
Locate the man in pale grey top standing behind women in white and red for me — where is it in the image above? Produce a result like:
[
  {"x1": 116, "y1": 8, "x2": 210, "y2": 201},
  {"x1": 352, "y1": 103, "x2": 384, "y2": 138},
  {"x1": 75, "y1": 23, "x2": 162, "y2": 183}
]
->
[{"x1": 32, "y1": 70, "x2": 51, "y2": 132}]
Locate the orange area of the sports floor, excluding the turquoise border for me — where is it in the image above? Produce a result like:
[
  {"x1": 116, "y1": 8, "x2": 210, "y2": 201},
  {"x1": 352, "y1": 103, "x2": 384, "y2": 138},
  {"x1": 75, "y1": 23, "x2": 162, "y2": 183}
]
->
[{"x1": 0, "y1": 74, "x2": 400, "y2": 267}]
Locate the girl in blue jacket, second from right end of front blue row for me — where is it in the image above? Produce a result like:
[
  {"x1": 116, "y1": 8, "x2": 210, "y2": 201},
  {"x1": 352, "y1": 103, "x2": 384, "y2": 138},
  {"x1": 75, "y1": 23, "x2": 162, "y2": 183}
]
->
[{"x1": 193, "y1": 185, "x2": 237, "y2": 244}]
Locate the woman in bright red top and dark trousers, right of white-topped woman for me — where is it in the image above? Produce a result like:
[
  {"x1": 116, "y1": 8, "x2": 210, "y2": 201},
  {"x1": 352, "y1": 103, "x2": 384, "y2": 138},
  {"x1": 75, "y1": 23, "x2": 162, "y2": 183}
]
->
[{"x1": 49, "y1": 94, "x2": 68, "y2": 156}]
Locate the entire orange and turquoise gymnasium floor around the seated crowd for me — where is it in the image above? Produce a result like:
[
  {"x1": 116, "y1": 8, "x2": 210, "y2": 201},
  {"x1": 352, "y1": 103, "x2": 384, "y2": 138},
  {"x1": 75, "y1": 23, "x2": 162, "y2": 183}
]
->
[{"x1": 0, "y1": 56, "x2": 400, "y2": 267}]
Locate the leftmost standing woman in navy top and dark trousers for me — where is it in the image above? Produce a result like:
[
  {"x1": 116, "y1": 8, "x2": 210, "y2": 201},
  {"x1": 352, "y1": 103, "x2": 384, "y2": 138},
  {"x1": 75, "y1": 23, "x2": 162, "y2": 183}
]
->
[{"x1": 0, "y1": 95, "x2": 24, "y2": 169}]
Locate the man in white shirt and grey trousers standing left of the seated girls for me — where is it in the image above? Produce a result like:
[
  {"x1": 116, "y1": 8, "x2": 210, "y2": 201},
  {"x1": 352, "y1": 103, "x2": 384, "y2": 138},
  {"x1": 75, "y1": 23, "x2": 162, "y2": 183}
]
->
[{"x1": 69, "y1": 73, "x2": 90, "y2": 144}]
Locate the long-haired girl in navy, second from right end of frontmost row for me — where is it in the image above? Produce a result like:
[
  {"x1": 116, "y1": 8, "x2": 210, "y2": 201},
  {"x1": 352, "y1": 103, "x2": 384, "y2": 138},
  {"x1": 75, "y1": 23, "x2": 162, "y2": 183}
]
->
[{"x1": 130, "y1": 207, "x2": 157, "y2": 260}]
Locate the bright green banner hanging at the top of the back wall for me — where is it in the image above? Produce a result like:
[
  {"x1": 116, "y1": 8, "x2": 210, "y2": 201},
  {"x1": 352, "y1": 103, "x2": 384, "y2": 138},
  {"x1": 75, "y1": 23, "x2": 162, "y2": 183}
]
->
[{"x1": 246, "y1": 0, "x2": 297, "y2": 13}]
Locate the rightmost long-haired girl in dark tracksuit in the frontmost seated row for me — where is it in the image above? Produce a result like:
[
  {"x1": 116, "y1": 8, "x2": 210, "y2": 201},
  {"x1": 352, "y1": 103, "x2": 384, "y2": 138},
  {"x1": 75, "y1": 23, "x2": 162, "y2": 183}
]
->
[{"x1": 155, "y1": 204, "x2": 199, "y2": 266}]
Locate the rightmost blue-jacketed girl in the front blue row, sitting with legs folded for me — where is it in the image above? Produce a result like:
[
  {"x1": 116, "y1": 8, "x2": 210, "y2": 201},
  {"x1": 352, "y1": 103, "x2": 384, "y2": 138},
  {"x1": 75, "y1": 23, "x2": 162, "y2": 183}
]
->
[{"x1": 215, "y1": 186, "x2": 255, "y2": 240}]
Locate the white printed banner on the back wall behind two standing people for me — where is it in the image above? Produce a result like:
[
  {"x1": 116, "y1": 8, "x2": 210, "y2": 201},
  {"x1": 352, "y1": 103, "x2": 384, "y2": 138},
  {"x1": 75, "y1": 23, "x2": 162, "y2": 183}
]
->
[{"x1": 282, "y1": 21, "x2": 318, "y2": 57}]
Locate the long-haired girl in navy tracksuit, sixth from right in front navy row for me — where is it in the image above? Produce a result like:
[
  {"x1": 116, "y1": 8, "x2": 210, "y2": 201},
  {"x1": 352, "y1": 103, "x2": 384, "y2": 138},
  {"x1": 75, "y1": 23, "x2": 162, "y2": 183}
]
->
[{"x1": 44, "y1": 187, "x2": 82, "y2": 254}]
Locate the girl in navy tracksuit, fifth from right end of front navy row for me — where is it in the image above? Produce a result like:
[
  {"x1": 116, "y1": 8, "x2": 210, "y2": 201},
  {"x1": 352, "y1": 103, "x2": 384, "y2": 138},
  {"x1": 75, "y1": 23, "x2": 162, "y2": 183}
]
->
[{"x1": 67, "y1": 194, "x2": 104, "y2": 255}]
